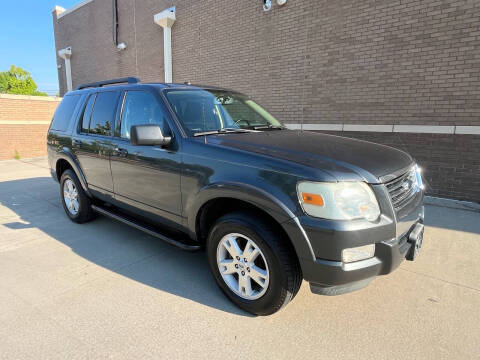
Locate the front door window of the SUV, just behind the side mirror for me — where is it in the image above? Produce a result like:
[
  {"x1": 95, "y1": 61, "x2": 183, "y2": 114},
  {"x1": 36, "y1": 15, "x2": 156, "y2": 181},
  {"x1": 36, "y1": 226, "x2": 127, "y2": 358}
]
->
[{"x1": 120, "y1": 91, "x2": 164, "y2": 139}]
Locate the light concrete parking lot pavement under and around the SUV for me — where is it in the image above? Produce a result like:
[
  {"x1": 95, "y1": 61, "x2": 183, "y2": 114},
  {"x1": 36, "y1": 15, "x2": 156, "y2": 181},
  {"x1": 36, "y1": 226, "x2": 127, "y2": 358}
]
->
[{"x1": 0, "y1": 158, "x2": 480, "y2": 359}]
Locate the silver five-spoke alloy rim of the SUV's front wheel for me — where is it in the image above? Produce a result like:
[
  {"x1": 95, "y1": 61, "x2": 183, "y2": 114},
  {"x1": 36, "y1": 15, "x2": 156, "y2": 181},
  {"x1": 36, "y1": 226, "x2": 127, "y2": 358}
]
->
[{"x1": 217, "y1": 233, "x2": 270, "y2": 300}]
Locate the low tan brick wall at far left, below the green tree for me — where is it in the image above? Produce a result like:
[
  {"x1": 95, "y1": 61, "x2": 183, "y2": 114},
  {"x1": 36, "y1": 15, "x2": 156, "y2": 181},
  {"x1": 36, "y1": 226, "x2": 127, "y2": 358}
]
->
[{"x1": 0, "y1": 94, "x2": 61, "y2": 160}]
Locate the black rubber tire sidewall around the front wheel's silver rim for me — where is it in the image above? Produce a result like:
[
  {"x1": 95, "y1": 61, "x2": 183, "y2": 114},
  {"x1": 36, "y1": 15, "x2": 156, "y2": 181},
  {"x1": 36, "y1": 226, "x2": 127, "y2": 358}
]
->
[{"x1": 207, "y1": 216, "x2": 287, "y2": 315}]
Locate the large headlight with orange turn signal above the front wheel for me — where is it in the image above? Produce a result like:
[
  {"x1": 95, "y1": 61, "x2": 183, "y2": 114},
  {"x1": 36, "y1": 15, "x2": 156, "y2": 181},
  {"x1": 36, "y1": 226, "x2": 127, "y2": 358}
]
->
[{"x1": 297, "y1": 181, "x2": 380, "y2": 221}]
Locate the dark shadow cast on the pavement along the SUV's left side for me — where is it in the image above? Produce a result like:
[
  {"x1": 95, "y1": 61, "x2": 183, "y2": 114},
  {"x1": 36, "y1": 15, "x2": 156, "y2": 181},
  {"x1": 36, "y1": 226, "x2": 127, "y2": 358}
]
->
[{"x1": 0, "y1": 177, "x2": 251, "y2": 316}]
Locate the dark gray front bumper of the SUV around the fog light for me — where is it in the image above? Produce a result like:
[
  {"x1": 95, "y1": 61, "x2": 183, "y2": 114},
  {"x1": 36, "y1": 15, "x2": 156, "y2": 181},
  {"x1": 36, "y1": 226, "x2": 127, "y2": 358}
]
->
[{"x1": 284, "y1": 188, "x2": 424, "y2": 295}]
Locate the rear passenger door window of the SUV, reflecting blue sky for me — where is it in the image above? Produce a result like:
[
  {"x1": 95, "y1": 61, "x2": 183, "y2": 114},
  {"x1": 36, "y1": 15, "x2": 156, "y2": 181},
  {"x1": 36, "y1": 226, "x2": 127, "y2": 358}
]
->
[{"x1": 89, "y1": 91, "x2": 119, "y2": 136}]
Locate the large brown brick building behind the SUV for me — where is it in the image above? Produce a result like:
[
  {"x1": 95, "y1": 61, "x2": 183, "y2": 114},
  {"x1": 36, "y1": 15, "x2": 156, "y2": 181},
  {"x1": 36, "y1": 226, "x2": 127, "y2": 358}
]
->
[{"x1": 53, "y1": 0, "x2": 480, "y2": 201}]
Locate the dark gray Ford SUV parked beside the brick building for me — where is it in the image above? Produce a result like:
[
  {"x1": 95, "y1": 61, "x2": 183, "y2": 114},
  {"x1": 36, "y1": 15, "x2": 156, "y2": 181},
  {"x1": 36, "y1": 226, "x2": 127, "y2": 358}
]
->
[{"x1": 47, "y1": 78, "x2": 424, "y2": 315}]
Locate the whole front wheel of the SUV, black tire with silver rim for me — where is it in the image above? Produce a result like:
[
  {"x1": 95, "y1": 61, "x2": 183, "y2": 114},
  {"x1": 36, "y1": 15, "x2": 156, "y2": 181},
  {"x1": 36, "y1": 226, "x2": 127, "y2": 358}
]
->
[{"x1": 206, "y1": 212, "x2": 302, "y2": 315}]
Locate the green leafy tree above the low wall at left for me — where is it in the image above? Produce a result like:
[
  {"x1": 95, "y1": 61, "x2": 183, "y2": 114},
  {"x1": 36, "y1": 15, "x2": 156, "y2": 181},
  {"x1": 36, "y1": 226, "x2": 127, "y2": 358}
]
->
[{"x1": 0, "y1": 65, "x2": 47, "y2": 96}]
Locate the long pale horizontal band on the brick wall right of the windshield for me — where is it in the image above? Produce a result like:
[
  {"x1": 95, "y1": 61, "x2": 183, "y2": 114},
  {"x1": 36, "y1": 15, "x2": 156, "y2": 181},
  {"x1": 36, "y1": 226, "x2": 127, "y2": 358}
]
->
[{"x1": 285, "y1": 124, "x2": 480, "y2": 135}]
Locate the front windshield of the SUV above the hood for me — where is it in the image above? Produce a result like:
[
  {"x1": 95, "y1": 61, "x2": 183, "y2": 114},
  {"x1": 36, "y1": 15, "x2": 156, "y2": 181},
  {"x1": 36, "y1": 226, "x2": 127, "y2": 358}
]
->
[{"x1": 165, "y1": 89, "x2": 283, "y2": 134}]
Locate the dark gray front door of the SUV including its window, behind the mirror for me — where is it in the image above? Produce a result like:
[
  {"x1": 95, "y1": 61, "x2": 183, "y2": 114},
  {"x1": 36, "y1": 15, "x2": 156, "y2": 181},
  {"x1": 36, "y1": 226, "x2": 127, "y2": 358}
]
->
[{"x1": 111, "y1": 90, "x2": 182, "y2": 223}]
